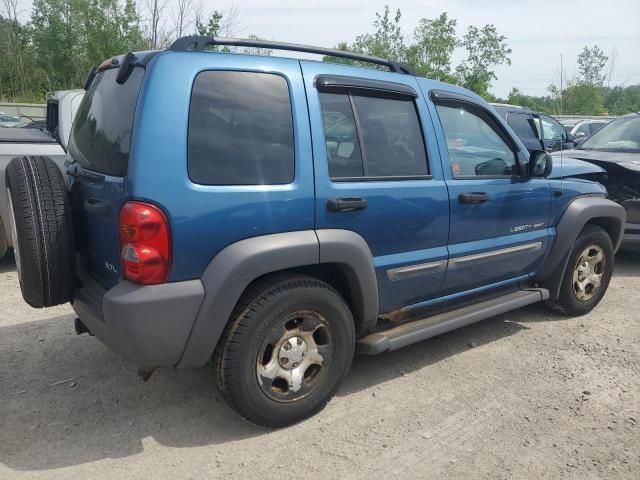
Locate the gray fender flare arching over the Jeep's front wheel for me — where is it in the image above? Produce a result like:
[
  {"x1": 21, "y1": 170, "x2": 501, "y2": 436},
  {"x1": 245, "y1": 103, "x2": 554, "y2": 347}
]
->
[{"x1": 535, "y1": 196, "x2": 627, "y2": 299}]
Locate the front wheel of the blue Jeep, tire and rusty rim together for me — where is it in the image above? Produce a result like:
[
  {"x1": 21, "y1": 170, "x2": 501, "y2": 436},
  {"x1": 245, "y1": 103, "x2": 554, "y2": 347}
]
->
[{"x1": 547, "y1": 225, "x2": 614, "y2": 316}]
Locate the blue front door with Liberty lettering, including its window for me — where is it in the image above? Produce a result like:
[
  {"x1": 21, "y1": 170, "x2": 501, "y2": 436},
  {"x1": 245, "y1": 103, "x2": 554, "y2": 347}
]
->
[{"x1": 434, "y1": 95, "x2": 551, "y2": 294}]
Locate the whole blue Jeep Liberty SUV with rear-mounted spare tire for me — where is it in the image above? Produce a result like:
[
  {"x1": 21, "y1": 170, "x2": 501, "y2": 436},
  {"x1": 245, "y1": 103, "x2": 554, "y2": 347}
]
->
[{"x1": 7, "y1": 37, "x2": 625, "y2": 427}]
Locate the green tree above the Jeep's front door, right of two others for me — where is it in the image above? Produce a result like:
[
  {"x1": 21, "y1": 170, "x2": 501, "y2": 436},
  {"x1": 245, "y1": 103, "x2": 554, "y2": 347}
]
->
[{"x1": 456, "y1": 25, "x2": 511, "y2": 96}]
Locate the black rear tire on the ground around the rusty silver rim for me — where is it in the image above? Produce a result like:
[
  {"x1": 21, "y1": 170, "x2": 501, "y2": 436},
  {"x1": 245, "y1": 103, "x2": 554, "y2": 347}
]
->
[{"x1": 214, "y1": 276, "x2": 355, "y2": 428}]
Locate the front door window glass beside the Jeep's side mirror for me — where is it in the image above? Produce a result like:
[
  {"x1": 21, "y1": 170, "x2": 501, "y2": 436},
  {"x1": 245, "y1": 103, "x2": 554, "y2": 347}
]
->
[{"x1": 436, "y1": 103, "x2": 517, "y2": 178}]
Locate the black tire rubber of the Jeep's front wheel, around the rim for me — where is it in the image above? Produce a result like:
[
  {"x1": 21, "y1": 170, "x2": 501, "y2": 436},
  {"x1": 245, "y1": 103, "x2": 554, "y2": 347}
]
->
[{"x1": 547, "y1": 225, "x2": 614, "y2": 317}]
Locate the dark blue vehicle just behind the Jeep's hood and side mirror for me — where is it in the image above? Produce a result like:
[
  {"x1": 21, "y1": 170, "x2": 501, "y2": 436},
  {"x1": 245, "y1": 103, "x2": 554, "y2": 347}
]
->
[{"x1": 492, "y1": 103, "x2": 575, "y2": 152}]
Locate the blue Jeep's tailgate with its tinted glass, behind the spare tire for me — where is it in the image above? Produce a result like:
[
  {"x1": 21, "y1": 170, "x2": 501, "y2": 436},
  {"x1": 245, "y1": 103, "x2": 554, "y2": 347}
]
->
[{"x1": 67, "y1": 67, "x2": 144, "y2": 288}]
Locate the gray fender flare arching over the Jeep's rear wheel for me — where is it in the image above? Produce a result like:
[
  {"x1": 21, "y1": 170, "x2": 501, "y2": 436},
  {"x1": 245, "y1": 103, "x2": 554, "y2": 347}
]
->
[{"x1": 178, "y1": 230, "x2": 378, "y2": 367}]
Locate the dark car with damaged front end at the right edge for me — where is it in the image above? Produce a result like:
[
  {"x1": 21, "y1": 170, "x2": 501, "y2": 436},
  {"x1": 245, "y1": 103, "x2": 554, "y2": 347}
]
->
[{"x1": 554, "y1": 113, "x2": 640, "y2": 250}]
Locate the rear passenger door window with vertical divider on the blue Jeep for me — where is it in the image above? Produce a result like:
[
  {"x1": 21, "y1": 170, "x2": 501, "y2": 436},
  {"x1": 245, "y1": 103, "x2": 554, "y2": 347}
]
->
[{"x1": 320, "y1": 92, "x2": 428, "y2": 179}]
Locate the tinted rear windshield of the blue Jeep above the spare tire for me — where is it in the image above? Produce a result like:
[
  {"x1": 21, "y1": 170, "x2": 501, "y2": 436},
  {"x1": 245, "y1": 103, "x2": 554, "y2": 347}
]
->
[{"x1": 70, "y1": 68, "x2": 144, "y2": 177}]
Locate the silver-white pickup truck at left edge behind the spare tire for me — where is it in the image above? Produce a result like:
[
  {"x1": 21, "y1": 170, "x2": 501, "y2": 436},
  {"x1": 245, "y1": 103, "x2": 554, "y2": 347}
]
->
[{"x1": 0, "y1": 90, "x2": 84, "y2": 257}]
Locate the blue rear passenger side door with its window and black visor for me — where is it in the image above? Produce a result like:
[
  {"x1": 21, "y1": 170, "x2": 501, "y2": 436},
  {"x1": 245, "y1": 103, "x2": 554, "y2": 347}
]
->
[{"x1": 301, "y1": 62, "x2": 449, "y2": 313}]
